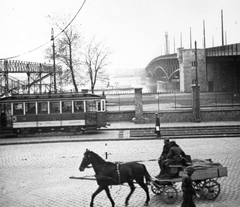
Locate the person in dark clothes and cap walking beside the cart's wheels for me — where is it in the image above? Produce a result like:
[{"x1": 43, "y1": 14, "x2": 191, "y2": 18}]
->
[{"x1": 181, "y1": 166, "x2": 197, "y2": 207}]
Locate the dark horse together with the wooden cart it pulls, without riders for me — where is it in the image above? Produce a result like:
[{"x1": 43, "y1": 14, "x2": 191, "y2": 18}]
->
[{"x1": 74, "y1": 149, "x2": 227, "y2": 207}]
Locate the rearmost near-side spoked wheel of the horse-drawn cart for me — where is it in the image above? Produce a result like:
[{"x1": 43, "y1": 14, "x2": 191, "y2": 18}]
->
[{"x1": 203, "y1": 180, "x2": 220, "y2": 200}]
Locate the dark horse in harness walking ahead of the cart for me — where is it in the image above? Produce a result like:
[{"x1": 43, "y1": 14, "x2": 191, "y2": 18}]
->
[{"x1": 79, "y1": 149, "x2": 151, "y2": 207}]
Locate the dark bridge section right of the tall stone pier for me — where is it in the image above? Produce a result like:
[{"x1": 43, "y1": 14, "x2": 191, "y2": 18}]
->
[{"x1": 205, "y1": 43, "x2": 240, "y2": 93}]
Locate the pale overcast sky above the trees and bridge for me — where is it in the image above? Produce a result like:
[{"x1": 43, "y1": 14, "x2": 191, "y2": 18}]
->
[{"x1": 0, "y1": 0, "x2": 240, "y2": 69}]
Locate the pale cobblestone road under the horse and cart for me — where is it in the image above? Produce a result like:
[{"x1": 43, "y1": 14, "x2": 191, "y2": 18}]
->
[{"x1": 0, "y1": 138, "x2": 240, "y2": 207}]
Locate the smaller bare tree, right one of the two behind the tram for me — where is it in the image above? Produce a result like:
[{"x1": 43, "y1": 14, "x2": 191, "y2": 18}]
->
[{"x1": 84, "y1": 41, "x2": 111, "y2": 93}]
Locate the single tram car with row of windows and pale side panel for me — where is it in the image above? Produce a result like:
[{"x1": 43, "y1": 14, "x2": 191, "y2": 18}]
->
[{"x1": 0, "y1": 93, "x2": 107, "y2": 134}]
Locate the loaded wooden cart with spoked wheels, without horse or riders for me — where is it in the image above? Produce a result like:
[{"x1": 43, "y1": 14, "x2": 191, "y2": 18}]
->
[{"x1": 151, "y1": 160, "x2": 227, "y2": 204}]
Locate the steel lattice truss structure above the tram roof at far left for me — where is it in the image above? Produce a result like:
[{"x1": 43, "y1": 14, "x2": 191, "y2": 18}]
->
[{"x1": 0, "y1": 60, "x2": 60, "y2": 95}]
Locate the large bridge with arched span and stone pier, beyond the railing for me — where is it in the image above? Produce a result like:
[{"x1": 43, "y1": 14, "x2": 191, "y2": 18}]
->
[{"x1": 145, "y1": 43, "x2": 240, "y2": 93}]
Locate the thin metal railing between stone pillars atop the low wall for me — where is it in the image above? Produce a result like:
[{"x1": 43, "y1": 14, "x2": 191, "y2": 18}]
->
[{"x1": 106, "y1": 92, "x2": 240, "y2": 112}]
